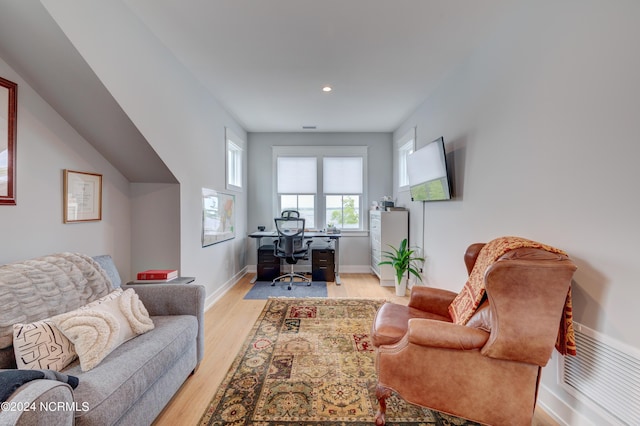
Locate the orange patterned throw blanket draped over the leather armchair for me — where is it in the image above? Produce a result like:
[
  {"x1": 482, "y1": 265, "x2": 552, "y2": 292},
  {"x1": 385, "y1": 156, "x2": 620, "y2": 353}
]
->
[{"x1": 449, "y1": 237, "x2": 576, "y2": 355}]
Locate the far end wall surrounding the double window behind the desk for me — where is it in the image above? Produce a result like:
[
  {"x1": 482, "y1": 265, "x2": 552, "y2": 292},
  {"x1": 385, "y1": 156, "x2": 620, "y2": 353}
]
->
[{"x1": 247, "y1": 132, "x2": 393, "y2": 272}]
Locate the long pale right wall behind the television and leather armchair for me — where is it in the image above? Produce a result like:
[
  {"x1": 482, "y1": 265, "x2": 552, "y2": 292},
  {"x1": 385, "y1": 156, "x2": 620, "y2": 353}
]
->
[{"x1": 394, "y1": 0, "x2": 640, "y2": 424}]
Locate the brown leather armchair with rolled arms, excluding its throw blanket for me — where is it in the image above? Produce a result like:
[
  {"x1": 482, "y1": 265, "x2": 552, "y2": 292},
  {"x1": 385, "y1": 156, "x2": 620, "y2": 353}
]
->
[{"x1": 372, "y1": 244, "x2": 576, "y2": 426}]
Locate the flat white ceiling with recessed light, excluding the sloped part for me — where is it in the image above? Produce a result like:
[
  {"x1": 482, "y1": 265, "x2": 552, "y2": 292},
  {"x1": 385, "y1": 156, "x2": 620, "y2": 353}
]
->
[{"x1": 123, "y1": 0, "x2": 517, "y2": 132}]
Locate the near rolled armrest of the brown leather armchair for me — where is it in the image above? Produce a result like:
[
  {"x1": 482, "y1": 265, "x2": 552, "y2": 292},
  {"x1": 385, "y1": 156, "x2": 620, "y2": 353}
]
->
[{"x1": 407, "y1": 318, "x2": 489, "y2": 350}]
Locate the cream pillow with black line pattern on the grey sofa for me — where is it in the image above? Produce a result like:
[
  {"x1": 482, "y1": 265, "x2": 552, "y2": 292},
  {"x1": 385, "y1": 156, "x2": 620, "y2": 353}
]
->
[{"x1": 13, "y1": 319, "x2": 77, "y2": 371}]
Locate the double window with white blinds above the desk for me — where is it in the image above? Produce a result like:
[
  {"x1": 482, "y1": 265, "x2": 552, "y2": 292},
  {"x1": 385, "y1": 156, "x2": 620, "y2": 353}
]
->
[{"x1": 273, "y1": 146, "x2": 367, "y2": 231}]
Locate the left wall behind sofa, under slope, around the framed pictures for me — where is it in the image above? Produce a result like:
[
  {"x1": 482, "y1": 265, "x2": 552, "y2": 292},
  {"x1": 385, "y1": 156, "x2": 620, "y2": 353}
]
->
[{"x1": 0, "y1": 58, "x2": 131, "y2": 271}]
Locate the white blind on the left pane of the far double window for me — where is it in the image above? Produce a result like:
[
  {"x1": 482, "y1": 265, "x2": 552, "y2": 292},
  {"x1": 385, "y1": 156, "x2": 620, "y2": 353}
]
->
[{"x1": 277, "y1": 157, "x2": 318, "y2": 194}]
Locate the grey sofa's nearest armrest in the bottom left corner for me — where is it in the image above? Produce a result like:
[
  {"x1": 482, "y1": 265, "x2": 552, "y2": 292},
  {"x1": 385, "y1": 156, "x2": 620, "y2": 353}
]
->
[{"x1": 0, "y1": 380, "x2": 74, "y2": 426}]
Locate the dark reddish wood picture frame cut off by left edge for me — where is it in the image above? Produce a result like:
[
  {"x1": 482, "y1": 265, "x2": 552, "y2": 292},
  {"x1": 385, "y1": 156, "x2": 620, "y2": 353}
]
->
[{"x1": 0, "y1": 77, "x2": 18, "y2": 206}]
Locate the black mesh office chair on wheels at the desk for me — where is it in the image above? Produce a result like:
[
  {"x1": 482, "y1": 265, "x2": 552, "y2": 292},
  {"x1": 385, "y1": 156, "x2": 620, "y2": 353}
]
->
[{"x1": 271, "y1": 217, "x2": 311, "y2": 290}]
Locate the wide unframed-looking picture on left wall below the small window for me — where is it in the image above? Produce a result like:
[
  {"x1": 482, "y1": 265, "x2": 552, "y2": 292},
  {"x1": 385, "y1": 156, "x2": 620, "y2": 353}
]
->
[{"x1": 202, "y1": 188, "x2": 236, "y2": 247}]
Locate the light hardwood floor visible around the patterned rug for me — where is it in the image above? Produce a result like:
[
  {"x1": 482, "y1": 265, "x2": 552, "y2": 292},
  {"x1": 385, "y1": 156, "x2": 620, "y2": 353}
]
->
[{"x1": 154, "y1": 274, "x2": 558, "y2": 426}]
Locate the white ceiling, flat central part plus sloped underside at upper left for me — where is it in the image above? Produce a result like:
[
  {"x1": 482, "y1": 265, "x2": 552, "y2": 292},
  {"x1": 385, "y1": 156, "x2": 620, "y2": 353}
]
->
[{"x1": 0, "y1": 0, "x2": 519, "y2": 182}]
